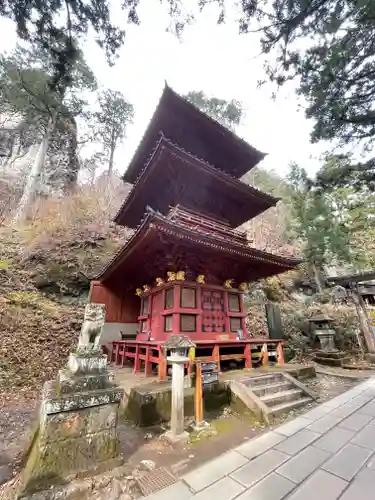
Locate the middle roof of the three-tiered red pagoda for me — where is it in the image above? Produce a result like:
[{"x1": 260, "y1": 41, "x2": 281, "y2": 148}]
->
[{"x1": 115, "y1": 136, "x2": 278, "y2": 228}]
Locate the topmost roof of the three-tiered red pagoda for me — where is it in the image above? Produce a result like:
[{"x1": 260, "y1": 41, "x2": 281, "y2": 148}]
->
[{"x1": 123, "y1": 85, "x2": 265, "y2": 183}]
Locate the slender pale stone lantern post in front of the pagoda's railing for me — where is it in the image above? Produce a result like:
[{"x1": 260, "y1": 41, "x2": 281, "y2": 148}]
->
[{"x1": 164, "y1": 335, "x2": 195, "y2": 442}]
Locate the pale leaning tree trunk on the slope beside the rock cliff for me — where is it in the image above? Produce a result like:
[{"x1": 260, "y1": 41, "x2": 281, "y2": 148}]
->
[{"x1": 13, "y1": 118, "x2": 55, "y2": 223}]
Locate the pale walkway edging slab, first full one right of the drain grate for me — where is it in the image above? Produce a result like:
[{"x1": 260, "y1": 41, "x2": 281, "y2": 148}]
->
[{"x1": 182, "y1": 451, "x2": 248, "y2": 492}]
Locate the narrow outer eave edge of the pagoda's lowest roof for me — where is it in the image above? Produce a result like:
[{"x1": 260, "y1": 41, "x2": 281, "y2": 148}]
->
[{"x1": 95, "y1": 213, "x2": 302, "y2": 281}]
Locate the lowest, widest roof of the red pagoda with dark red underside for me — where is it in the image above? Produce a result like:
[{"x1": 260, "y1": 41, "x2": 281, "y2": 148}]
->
[{"x1": 95, "y1": 211, "x2": 301, "y2": 289}]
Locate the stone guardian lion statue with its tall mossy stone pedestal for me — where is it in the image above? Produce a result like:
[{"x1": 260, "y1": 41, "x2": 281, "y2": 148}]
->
[{"x1": 21, "y1": 304, "x2": 123, "y2": 493}]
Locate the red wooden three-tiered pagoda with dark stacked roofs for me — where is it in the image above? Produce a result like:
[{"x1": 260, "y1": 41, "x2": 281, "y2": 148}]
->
[{"x1": 89, "y1": 86, "x2": 300, "y2": 379}]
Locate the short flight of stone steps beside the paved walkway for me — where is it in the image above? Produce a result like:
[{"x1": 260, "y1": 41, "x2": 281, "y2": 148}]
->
[{"x1": 230, "y1": 372, "x2": 316, "y2": 423}]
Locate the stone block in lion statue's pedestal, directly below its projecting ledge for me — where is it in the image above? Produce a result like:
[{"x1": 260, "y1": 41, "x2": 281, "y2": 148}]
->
[{"x1": 42, "y1": 403, "x2": 118, "y2": 442}]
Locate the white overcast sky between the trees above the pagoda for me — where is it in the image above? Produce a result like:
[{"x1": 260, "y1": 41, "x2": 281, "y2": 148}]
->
[{"x1": 0, "y1": 1, "x2": 324, "y2": 175}]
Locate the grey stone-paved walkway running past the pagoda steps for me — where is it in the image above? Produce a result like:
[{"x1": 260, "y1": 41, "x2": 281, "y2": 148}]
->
[{"x1": 147, "y1": 377, "x2": 375, "y2": 500}]
